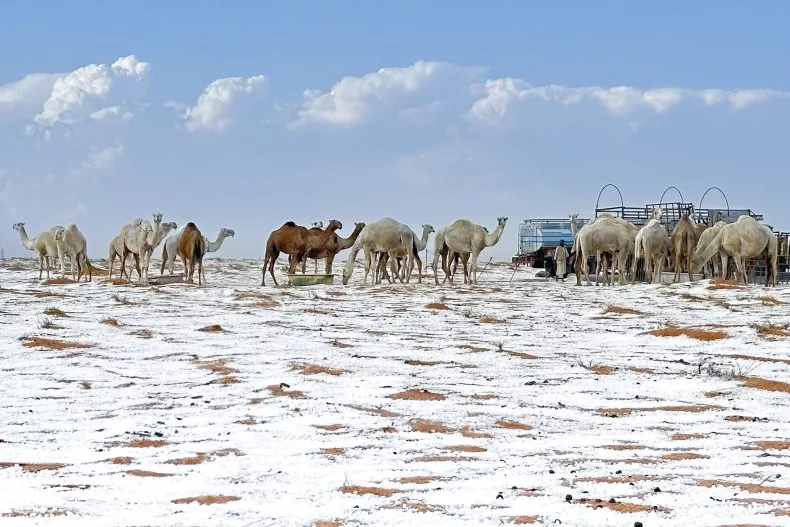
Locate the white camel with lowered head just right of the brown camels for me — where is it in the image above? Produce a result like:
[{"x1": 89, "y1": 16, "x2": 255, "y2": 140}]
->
[{"x1": 343, "y1": 218, "x2": 424, "y2": 285}]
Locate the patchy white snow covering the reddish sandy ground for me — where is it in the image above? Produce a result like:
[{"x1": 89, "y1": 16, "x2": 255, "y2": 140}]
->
[{"x1": 0, "y1": 259, "x2": 790, "y2": 527}]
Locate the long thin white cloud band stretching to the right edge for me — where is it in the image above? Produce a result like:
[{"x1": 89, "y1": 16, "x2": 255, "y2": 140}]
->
[{"x1": 467, "y1": 77, "x2": 790, "y2": 125}]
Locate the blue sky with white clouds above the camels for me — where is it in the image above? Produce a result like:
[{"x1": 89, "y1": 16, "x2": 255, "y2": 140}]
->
[{"x1": 0, "y1": 0, "x2": 790, "y2": 258}]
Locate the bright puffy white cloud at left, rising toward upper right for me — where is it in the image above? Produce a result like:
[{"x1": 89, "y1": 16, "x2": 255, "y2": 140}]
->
[{"x1": 33, "y1": 55, "x2": 150, "y2": 126}]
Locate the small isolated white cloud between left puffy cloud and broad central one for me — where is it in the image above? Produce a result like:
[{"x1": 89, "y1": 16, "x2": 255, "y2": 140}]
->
[{"x1": 185, "y1": 75, "x2": 268, "y2": 132}]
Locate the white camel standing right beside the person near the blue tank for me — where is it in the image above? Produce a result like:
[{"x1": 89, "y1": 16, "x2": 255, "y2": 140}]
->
[{"x1": 573, "y1": 214, "x2": 636, "y2": 286}]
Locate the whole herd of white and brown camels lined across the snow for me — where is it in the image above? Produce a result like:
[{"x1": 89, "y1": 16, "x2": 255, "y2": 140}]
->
[{"x1": 13, "y1": 207, "x2": 777, "y2": 287}]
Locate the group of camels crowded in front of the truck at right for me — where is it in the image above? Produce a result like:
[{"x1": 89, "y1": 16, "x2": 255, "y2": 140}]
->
[{"x1": 571, "y1": 207, "x2": 778, "y2": 287}]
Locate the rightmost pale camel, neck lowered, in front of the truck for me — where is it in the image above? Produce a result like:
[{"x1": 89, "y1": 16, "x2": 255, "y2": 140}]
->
[{"x1": 689, "y1": 215, "x2": 777, "y2": 286}]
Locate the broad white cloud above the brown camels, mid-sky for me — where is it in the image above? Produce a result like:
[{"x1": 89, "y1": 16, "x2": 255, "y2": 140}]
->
[{"x1": 291, "y1": 60, "x2": 482, "y2": 127}]
